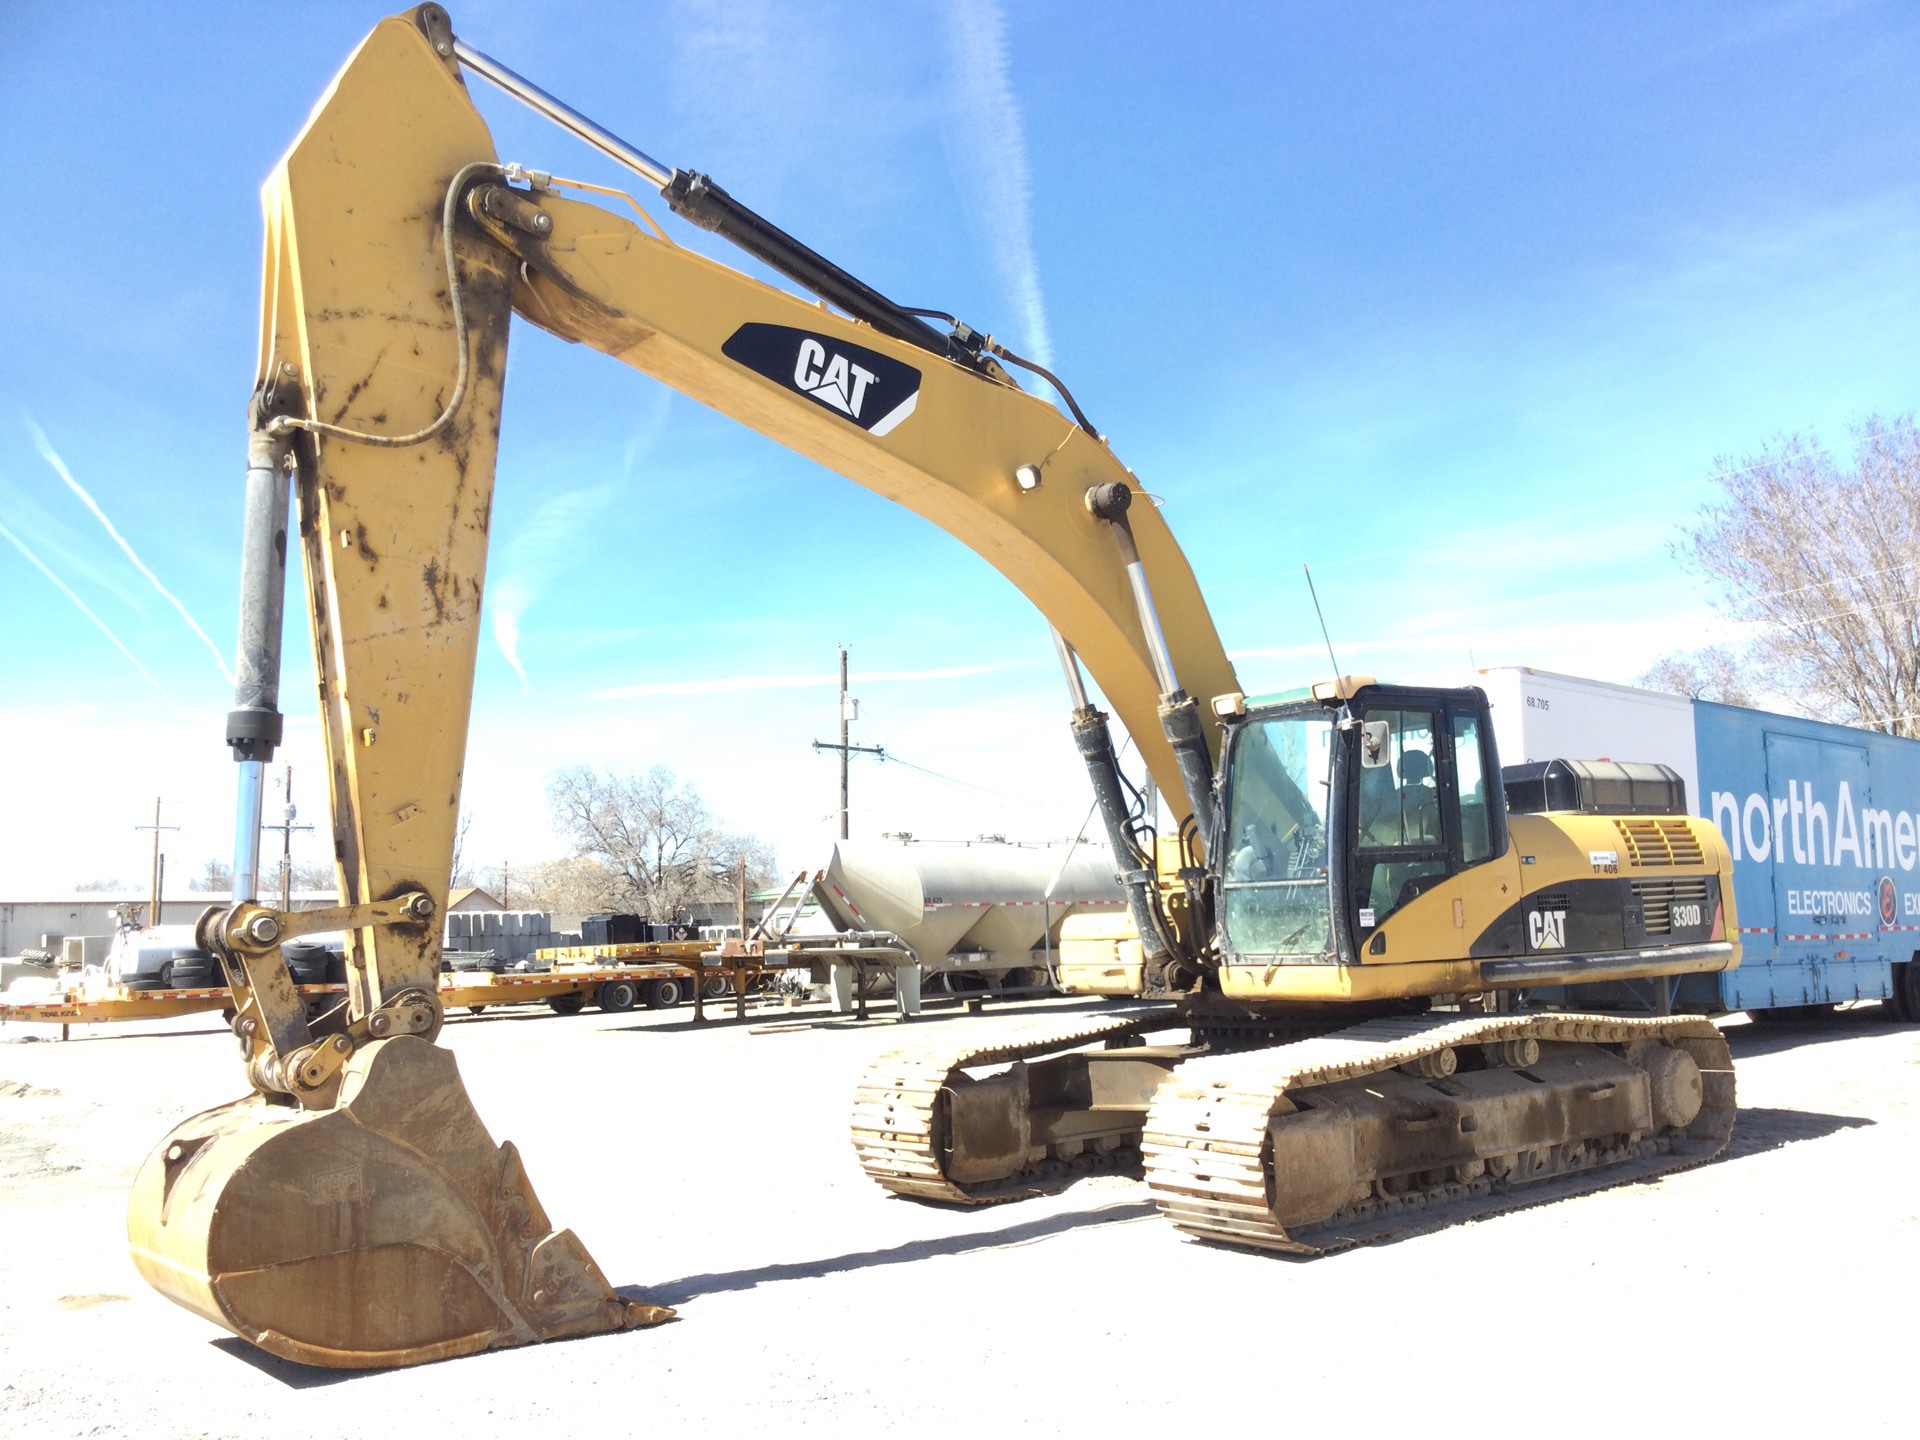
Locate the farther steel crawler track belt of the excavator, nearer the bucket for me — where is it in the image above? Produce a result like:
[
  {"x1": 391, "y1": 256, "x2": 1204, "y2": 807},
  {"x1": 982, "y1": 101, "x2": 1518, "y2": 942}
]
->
[{"x1": 852, "y1": 1010, "x2": 1183, "y2": 1206}]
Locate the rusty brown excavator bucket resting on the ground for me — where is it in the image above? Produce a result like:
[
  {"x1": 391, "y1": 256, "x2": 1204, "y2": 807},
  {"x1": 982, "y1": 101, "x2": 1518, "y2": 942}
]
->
[{"x1": 127, "y1": 1035, "x2": 674, "y2": 1369}]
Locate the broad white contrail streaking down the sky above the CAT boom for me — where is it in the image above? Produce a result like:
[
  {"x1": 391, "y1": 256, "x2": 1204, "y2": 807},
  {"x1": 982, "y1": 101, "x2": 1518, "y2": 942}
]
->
[{"x1": 947, "y1": 0, "x2": 1054, "y2": 367}]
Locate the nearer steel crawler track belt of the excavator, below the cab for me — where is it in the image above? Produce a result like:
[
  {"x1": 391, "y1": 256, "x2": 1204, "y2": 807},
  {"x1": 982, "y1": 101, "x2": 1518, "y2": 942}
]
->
[{"x1": 1142, "y1": 1016, "x2": 1734, "y2": 1256}]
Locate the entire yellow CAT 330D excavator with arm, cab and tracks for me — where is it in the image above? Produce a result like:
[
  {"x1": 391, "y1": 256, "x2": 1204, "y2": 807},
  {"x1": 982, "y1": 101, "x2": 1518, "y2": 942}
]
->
[{"x1": 129, "y1": 4, "x2": 1738, "y2": 1367}]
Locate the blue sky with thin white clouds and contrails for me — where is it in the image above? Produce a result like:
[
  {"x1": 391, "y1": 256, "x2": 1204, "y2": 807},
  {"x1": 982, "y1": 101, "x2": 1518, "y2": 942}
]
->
[{"x1": 0, "y1": 0, "x2": 1920, "y2": 895}]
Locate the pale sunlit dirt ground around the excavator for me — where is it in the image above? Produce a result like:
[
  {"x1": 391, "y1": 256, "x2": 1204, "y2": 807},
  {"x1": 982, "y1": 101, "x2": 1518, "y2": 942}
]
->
[{"x1": 0, "y1": 1002, "x2": 1920, "y2": 1440}]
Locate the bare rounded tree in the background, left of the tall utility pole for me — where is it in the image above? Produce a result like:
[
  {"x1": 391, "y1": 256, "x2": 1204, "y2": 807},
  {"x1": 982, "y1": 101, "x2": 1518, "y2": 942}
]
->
[{"x1": 547, "y1": 764, "x2": 774, "y2": 920}]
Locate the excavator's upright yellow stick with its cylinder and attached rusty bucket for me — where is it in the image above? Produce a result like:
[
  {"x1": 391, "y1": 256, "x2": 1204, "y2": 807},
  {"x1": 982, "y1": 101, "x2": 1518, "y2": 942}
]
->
[{"x1": 129, "y1": 6, "x2": 672, "y2": 1369}]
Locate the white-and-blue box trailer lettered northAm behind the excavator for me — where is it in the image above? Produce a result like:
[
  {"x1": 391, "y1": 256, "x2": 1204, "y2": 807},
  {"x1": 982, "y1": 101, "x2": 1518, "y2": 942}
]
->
[{"x1": 1475, "y1": 668, "x2": 1920, "y2": 1020}]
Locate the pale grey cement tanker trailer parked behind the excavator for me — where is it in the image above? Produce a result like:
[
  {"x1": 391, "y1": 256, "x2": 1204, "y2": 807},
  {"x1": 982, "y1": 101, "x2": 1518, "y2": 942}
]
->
[{"x1": 787, "y1": 839, "x2": 1127, "y2": 993}]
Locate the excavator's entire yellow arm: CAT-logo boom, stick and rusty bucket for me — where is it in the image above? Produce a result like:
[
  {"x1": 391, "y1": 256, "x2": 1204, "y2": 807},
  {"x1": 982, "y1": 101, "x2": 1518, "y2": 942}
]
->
[{"x1": 129, "y1": 6, "x2": 1235, "y2": 1367}]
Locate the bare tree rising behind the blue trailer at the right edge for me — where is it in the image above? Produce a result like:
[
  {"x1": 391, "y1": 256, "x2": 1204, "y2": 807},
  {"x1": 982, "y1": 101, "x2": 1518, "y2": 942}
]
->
[{"x1": 1678, "y1": 415, "x2": 1920, "y2": 735}]
